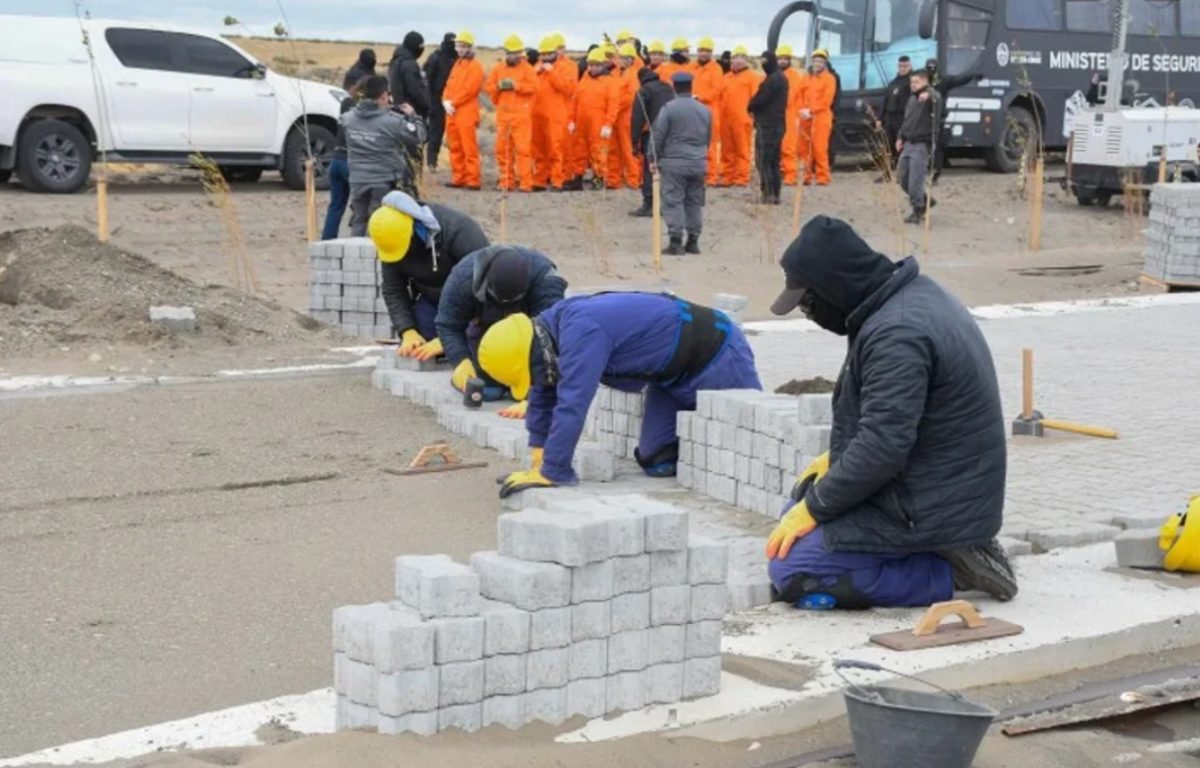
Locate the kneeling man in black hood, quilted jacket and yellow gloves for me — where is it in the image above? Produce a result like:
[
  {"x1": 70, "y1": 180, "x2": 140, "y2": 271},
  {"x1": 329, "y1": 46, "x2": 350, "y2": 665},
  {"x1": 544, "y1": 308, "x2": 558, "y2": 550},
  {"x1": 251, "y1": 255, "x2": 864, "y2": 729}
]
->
[{"x1": 767, "y1": 216, "x2": 1018, "y2": 608}]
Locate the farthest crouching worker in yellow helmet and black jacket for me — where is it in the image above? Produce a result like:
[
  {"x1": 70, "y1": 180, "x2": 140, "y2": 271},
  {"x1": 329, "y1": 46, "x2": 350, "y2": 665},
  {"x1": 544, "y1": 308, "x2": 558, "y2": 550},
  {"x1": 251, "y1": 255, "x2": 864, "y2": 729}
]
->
[{"x1": 367, "y1": 192, "x2": 487, "y2": 359}]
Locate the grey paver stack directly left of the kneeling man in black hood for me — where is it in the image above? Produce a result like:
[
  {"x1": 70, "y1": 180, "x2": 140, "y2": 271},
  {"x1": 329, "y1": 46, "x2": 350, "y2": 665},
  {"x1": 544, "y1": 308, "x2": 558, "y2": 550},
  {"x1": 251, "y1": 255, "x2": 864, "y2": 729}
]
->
[{"x1": 677, "y1": 390, "x2": 833, "y2": 517}]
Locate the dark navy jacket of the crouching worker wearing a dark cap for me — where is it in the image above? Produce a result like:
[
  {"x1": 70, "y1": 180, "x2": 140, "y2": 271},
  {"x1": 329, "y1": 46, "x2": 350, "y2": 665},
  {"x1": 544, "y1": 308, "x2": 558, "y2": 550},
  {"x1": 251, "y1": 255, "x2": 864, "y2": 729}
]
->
[{"x1": 437, "y1": 245, "x2": 566, "y2": 370}]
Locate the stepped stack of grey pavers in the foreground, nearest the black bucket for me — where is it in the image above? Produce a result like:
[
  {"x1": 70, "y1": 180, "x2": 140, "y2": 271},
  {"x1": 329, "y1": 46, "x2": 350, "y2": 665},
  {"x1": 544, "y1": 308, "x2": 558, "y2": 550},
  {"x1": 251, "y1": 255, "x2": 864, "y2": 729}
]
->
[{"x1": 334, "y1": 496, "x2": 728, "y2": 734}]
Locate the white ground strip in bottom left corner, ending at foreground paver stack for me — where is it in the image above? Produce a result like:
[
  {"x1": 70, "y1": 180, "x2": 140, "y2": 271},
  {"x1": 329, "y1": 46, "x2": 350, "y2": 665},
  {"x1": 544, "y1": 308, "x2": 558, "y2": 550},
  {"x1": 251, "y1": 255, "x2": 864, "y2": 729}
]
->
[{"x1": 0, "y1": 688, "x2": 337, "y2": 768}]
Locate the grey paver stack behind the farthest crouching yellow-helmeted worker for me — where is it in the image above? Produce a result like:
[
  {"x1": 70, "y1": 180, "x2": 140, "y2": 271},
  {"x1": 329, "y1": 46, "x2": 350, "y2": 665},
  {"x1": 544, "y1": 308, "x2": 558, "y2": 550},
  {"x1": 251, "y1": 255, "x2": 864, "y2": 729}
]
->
[{"x1": 308, "y1": 238, "x2": 391, "y2": 338}]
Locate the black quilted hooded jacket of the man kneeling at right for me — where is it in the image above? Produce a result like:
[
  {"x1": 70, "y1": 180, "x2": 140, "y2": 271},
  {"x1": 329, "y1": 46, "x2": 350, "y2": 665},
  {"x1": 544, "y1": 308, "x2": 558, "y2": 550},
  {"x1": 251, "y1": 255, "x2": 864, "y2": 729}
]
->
[{"x1": 797, "y1": 222, "x2": 1007, "y2": 553}]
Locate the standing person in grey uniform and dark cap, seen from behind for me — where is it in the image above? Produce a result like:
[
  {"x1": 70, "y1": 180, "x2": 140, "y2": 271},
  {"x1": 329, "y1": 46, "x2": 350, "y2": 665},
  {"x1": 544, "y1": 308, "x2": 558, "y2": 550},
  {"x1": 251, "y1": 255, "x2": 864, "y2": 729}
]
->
[{"x1": 654, "y1": 72, "x2": 713, "y2": 256}]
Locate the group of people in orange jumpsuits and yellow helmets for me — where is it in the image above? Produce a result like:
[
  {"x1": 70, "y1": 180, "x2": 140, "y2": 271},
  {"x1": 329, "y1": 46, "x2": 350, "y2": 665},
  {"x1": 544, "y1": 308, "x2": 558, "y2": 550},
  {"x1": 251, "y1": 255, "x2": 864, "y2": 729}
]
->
[{"x1": 442, "y1": 31, "x2": 839, "y2": 192}]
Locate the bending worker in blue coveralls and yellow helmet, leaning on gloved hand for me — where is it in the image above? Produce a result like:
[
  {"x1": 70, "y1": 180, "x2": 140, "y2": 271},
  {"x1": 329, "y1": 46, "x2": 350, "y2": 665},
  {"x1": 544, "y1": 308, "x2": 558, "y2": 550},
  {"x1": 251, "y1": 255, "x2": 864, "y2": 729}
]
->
[{"x1": 479, "y1": 293, "x2": 762, "y2": 498}]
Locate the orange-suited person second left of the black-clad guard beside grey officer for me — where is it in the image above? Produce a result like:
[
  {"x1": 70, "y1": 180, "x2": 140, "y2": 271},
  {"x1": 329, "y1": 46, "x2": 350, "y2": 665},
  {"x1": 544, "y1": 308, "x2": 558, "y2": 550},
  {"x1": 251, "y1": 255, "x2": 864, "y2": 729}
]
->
[{"x1": 563, "y1": 48, "x2": 620, "y2": 190}]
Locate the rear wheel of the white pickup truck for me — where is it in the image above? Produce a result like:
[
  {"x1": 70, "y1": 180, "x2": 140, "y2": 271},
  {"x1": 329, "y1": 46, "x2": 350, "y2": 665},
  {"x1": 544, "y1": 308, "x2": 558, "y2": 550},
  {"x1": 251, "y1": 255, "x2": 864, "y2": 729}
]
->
[{"x1": 17, "y1": 120, "x2": 91, "y2": 193}]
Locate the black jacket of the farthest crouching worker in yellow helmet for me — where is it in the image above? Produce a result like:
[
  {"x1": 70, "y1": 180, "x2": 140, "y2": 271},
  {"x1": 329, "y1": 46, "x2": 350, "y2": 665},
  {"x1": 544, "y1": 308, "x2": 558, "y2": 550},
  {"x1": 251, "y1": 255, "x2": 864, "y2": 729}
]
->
[{"x1": 379, "y1": 203, "x2": 487, "y2": 334}]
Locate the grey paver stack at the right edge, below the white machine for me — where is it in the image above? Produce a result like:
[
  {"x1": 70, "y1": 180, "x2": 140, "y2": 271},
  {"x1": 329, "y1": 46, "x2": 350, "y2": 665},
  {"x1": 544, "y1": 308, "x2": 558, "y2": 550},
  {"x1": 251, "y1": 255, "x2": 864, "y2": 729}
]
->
[{"x1": 1142, "y1": 184, "x2": 1200, "y2": 287}]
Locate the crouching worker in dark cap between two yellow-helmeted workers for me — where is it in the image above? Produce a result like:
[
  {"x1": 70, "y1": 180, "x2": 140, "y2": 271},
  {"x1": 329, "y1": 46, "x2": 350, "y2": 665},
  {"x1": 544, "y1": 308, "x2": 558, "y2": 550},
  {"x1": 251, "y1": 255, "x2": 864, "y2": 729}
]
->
[{"x1": 432, "y1": 245, "x2": 566, "y2": 419}]
